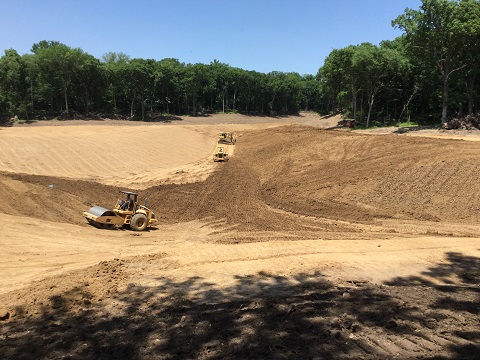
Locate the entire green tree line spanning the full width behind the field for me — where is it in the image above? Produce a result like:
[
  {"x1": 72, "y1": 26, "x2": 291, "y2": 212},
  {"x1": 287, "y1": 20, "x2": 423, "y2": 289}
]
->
[{"x1": 0, "y1": 0, "x2": 480, "y2": 127}]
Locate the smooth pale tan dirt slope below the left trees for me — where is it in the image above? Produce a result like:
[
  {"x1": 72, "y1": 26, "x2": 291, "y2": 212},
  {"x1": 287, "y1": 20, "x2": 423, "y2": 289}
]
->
[{"x1": 0, "y1": 126, "x2": 214, "y2": 182}]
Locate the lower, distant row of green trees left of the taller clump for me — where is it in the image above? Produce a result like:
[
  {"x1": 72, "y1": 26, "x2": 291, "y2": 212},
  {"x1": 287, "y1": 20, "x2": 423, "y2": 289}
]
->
[{"x1": 0, "y1": 41, "x2": 319, "y2": 120}]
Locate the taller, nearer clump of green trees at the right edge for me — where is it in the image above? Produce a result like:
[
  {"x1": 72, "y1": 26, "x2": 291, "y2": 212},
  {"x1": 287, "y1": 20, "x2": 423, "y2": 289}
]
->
[{"x1": 317, "y1": 0, "x2": 480, "y2": 127}]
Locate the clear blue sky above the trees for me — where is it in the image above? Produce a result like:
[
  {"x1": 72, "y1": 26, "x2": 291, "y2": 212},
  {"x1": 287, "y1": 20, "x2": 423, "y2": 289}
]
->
[{"x1": 0, "y1": 0, "x2": 421, "y2": 75}]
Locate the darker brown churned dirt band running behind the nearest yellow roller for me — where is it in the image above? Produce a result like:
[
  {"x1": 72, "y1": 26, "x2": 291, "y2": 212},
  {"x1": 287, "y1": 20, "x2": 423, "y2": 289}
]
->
[{"x1": 0, "y1": 126, "x2": 480, "y2": 231}]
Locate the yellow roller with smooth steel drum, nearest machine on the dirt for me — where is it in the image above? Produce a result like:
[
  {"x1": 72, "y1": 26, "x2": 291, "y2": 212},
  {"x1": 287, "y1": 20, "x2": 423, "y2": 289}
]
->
[{"x1": 83, "y1": 190, "x2": 158, "y2": 231}]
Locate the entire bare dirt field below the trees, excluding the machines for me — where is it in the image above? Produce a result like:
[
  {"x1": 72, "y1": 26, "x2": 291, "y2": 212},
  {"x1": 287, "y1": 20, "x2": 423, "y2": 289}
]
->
[{"x1": 0, "y1": 114, "x2": 480, "y2": 359}]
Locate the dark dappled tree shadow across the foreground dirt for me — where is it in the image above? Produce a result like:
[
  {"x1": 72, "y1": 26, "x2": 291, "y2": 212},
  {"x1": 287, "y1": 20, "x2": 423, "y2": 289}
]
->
[{"x1": 0, "y1": 253, "x2": 480, "y2": 359}]
